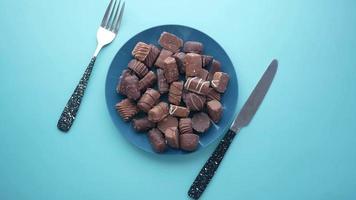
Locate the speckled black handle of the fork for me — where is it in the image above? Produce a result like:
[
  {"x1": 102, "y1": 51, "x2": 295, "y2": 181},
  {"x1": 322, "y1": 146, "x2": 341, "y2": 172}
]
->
[{"x1": 57, "y1": 57, "x2": 96, "y2": 132}]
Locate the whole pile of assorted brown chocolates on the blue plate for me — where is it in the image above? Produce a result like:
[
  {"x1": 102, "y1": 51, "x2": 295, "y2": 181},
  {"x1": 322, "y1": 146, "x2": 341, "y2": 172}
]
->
[{"x1": 116, "y1": 32, "x2": 229, "y2": 153}]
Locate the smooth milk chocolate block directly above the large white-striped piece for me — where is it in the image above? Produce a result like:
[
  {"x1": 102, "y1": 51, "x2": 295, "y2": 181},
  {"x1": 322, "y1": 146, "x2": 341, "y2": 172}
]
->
[{"x1": 184, "y1": 53, "x2": 202, "y2": 76}]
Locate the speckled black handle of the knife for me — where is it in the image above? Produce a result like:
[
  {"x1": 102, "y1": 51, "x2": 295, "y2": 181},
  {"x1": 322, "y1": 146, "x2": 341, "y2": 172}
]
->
[{"x1": 188, "y1": 130, "x2": 236, "y2": 199}]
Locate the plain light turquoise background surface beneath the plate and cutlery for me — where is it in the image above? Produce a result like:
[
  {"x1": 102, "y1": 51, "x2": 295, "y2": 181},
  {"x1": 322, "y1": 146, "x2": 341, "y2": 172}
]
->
[{"x1": 0, "y1": 0, "x2": 356, "y2": 200}]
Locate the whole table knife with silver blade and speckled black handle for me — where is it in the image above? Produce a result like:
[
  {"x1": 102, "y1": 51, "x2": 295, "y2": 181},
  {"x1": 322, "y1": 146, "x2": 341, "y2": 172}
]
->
[{"x1": 188, "y1": 60, "x2": 278, "y2": 199}]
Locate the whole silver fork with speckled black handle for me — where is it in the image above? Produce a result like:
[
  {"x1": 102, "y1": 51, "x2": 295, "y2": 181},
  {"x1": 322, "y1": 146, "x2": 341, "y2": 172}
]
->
[{"x1": 57, "y1": 0, "x2": 125, "y2": 132}]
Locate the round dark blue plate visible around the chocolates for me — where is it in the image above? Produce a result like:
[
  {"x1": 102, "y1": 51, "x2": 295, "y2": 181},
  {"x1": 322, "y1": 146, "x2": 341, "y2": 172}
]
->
[{"x1": 105, "y1": 25, "x2": 238, "y2": 154}]
